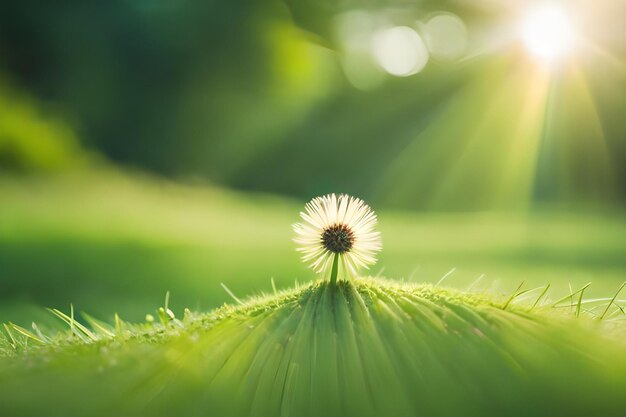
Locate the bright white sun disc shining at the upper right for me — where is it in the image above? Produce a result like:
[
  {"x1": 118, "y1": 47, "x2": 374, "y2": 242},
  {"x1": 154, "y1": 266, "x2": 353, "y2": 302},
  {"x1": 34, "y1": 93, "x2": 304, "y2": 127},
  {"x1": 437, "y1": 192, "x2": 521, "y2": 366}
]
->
[{"x1": 521, "y1": 5, "x2": 574, "y2": 62}]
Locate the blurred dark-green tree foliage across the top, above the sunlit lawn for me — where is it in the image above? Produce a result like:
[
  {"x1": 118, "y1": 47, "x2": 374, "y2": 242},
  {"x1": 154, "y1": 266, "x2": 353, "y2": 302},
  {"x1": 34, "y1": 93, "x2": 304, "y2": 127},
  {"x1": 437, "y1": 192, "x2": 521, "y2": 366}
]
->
[{"x1": 0, "y1": 0, "x2": 626, "y2": 209}]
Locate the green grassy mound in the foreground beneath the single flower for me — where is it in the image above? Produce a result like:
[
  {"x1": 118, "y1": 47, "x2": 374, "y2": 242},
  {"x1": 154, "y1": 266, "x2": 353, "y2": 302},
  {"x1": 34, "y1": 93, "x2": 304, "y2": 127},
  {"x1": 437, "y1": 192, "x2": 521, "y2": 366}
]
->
[{"x1": 0, "y1": 279, "x2": 626, "y2": 417}]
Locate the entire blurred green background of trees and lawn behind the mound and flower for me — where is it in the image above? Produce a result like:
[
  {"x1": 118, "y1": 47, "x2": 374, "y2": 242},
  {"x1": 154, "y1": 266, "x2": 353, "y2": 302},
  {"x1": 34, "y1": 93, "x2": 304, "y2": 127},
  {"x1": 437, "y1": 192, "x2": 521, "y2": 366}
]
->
[{"x1": 0, "y1": 0, "x2": 626, "y2": 323}]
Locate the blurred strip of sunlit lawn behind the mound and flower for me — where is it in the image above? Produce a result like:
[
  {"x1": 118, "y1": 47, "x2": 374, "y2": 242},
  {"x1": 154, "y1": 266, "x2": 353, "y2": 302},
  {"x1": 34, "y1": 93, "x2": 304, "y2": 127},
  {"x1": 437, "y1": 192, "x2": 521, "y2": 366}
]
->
[{"x1": 0, "y1": 170, "x2": 626, "y2": 326}]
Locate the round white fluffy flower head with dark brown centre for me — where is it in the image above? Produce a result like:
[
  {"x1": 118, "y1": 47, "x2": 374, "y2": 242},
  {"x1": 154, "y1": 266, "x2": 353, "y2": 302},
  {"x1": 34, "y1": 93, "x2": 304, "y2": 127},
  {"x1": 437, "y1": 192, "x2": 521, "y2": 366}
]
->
[{"x1": 293, "y1": 194, "x2": 382, "y2": 281}]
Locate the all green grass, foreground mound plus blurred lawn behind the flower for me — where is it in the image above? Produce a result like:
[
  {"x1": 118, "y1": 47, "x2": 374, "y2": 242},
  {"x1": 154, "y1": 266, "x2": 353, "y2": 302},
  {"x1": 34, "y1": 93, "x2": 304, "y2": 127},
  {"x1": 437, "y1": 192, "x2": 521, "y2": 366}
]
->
[{"x1": 0, "y1": 171, "x2": 626, "y2": 417}]
